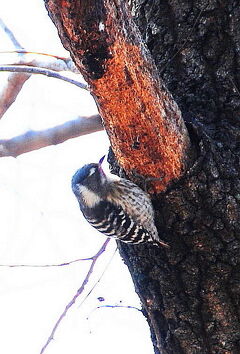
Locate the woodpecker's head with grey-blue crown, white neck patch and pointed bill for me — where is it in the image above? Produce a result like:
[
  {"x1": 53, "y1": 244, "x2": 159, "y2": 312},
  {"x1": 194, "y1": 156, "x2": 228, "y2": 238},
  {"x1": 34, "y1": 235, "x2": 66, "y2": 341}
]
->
[{"x1": 72, "y1": 157, "x2": 107, "y2": 207}]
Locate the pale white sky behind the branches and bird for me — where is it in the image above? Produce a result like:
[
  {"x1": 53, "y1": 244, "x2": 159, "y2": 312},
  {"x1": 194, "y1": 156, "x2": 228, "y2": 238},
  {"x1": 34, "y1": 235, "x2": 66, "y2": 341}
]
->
[{"x1": 0, "y1": 0, "x2": 153, "y2": 354}]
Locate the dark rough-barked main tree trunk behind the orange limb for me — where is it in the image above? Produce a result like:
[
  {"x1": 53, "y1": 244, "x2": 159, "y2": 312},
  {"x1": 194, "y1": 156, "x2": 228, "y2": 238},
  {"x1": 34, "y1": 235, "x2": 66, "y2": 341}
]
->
[{"x1": 46, "y1": 0, "x2": 240, "y2": 354}]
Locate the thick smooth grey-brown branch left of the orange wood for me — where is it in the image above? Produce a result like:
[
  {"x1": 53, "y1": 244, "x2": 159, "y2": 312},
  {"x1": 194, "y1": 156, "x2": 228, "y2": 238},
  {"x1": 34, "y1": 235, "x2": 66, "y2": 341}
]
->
[{"x1": 0, "y1": 114, "x2": 103, "y2": 157}]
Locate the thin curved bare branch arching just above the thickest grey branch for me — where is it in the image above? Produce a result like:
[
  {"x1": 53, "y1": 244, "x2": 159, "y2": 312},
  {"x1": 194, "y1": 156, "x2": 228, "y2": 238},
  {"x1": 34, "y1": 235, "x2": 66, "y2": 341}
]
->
[{"x1": 0, "y1": 65, "x2": 88, "y2": 90}]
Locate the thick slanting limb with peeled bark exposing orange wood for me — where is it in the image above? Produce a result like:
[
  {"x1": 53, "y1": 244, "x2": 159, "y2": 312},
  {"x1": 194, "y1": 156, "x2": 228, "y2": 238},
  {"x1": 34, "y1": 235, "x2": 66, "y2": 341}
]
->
[{"x1": 46, "y1": 0, "x2": 189, "y2": 191}]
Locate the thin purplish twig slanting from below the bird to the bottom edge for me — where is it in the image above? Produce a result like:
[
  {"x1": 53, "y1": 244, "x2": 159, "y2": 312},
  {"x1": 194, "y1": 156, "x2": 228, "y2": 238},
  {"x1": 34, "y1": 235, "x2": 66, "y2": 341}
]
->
[{"x1": 40, "y1": 238, "x2": 110, "y2": 354}]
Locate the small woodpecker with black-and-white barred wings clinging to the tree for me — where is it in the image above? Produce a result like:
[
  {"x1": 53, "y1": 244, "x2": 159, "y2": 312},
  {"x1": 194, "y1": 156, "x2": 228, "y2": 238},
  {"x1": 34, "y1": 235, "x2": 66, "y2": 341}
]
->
[{"x1": 72, "y1": 157, "x2": 169, "y2": 247}]
